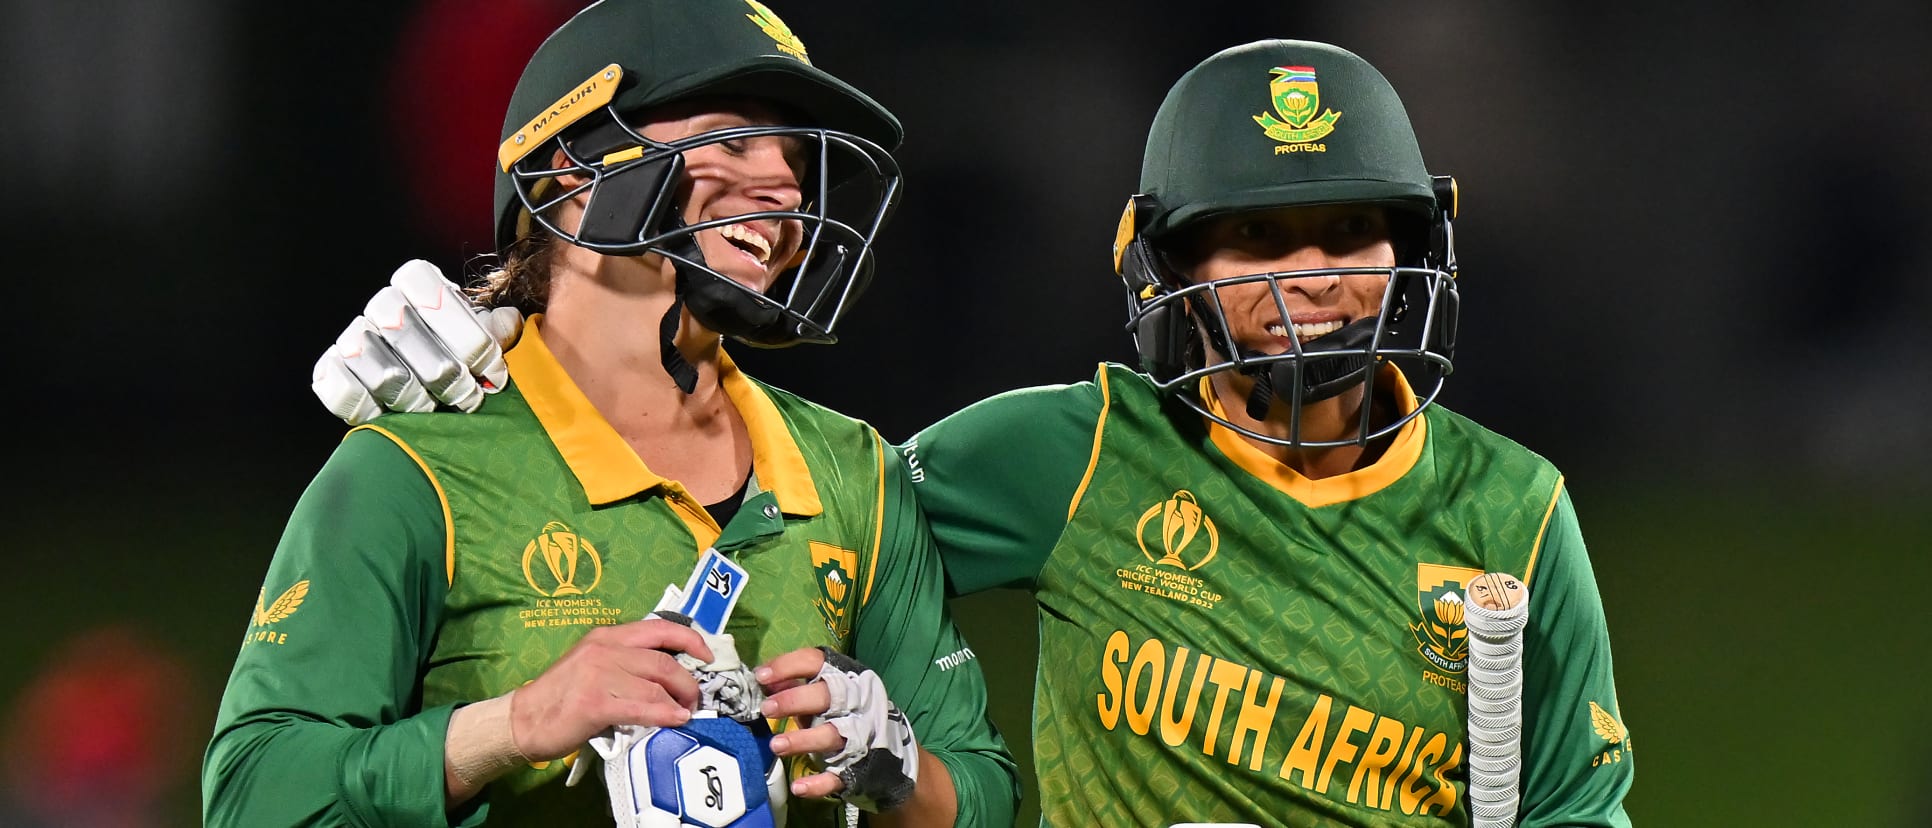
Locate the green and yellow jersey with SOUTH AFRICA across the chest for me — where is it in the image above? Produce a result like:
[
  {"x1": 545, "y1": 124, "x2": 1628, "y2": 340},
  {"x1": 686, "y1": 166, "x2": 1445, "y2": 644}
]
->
[{"x1": 900, "y1": 365, "x2": 1633, "y2": 828}]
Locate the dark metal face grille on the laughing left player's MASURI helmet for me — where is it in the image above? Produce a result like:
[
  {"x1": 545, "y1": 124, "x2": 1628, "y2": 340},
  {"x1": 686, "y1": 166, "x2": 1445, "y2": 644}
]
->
[{"x1": 510, "y1": 106, "x2": 900, "y2": 347}]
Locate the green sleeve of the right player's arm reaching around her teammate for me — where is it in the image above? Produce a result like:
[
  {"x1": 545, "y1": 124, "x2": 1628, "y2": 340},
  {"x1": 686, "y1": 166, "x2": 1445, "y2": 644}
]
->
[{"x1": 900, "y1": 369, "x2": 1107, "y2": 594}]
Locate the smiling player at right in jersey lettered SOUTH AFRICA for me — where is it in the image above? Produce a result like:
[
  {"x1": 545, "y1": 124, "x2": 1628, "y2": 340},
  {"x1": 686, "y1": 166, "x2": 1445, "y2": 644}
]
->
[{"x1": 317, "y1": 41, "x2": 1634, "y2": 826}]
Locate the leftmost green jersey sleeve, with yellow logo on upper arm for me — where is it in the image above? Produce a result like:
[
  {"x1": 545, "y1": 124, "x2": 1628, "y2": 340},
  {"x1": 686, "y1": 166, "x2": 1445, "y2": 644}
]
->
[{"x1": 201, "y1": 430, "x2": 467, "y2": 826}]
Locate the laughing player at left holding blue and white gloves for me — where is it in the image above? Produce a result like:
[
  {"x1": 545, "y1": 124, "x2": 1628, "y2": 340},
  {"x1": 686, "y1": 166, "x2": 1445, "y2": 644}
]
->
[{"x1": 203, "y1": 0, "x2": 1018, "y2": 826}]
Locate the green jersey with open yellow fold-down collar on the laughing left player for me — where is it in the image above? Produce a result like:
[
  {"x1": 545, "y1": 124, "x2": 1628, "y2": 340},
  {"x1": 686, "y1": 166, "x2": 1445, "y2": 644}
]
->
[{"x1": 203, "y1": 317, "x2": 1018, "y2": 826}]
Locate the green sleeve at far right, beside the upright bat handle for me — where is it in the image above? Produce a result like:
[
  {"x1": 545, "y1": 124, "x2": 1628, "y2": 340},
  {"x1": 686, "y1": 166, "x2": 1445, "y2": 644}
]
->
[{"x1": 1519, "y1": 492, "x2": 1636, "y2": 828}]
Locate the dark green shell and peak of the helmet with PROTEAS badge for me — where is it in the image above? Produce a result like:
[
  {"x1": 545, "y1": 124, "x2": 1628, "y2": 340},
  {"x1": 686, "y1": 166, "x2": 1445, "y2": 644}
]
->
[{"x1": 1140, "y1": 41, "x2": 1435, "y2": 239}]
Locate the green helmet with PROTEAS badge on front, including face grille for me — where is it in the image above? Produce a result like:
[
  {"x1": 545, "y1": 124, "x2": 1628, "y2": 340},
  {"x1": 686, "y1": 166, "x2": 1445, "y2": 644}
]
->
[{"x1": 1113, "y1": 41, "x2": 1459, "y2": 448}]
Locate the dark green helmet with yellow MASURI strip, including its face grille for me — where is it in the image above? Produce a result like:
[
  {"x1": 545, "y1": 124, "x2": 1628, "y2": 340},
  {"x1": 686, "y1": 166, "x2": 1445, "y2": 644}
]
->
[{"x1": 497, "y1": 0, "x2": 902, "y2": 370}]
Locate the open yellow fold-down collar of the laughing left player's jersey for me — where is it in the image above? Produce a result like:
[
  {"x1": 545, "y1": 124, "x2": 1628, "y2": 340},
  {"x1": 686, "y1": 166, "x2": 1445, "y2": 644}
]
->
[{"x1": 504, "y1": 313, "x2": 825, "y2": 517}]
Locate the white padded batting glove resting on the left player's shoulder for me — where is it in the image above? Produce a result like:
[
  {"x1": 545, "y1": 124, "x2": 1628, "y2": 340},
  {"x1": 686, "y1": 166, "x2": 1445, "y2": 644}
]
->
[{"x1": 309, "y1": 259, "x2": 524, "y2": 425}]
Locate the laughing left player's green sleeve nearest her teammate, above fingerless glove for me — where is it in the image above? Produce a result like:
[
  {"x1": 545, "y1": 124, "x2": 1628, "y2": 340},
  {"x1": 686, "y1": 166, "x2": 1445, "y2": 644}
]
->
[{"x1": 852, "y1": 428, "x2": 1020, "y2": 826}]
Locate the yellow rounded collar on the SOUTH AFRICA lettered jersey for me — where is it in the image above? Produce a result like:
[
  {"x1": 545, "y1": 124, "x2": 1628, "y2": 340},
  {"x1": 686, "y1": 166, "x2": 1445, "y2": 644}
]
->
[{"x1": 1200, "y1": 365, "x2": 1430, "y2": 508}]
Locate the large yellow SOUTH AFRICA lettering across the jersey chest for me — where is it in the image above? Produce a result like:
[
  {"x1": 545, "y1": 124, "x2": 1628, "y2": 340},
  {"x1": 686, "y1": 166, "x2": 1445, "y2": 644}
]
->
[{"x1": 1097, "y1": 629, "x2": 1463, "y2": 814}]
